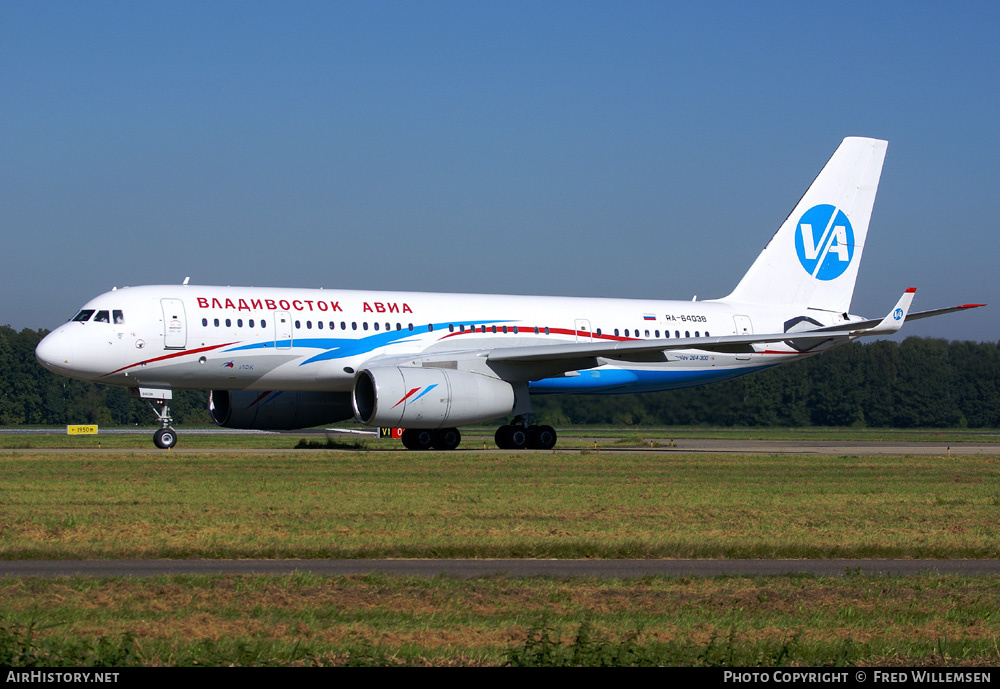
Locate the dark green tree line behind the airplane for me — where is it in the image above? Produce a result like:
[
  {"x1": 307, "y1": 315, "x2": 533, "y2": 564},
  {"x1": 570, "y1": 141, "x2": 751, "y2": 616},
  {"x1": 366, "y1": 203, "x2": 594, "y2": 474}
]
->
[{"x1": 0, "y1": 326, "x2": 1000, "y2": 428}]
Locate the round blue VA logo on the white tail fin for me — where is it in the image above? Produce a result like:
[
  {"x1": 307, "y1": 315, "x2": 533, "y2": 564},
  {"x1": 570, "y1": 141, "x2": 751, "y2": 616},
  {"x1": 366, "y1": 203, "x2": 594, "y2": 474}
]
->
[{"x1": 795, "y1": 204, "x2": 854, "y2": 280}]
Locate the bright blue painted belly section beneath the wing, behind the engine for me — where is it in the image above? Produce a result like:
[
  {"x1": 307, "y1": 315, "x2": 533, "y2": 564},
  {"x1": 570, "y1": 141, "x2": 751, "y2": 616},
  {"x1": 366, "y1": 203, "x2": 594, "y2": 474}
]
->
[{"x1": 528, "y1": 364, "x2": 775, "y2": 395}]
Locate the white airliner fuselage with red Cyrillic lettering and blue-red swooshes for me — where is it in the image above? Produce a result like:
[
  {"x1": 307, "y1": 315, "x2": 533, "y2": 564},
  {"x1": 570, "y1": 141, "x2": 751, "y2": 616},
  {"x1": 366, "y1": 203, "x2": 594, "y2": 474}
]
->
[{"x1": 37, "y1": 285, "x2": 845, "y2": 393}]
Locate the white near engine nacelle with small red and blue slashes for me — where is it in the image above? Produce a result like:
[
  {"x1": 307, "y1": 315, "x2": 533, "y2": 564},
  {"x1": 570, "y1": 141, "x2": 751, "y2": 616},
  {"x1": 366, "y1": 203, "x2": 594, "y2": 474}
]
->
[{"x1": 351, "y1": 366, "x2": 514, "y2": 428}]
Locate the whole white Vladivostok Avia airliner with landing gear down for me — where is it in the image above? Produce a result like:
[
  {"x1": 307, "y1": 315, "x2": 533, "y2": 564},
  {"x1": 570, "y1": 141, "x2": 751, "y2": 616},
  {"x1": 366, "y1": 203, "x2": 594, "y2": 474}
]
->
[{"x1": 35, "y1": 137, "x2": 983, "y2": 450}]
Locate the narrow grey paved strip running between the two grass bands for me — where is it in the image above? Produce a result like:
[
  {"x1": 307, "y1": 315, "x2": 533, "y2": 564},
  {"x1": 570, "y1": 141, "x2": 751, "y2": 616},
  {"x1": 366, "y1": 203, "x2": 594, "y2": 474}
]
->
[{"x1": 0, "y1": 560, "x2": 1000, "y2": 579}]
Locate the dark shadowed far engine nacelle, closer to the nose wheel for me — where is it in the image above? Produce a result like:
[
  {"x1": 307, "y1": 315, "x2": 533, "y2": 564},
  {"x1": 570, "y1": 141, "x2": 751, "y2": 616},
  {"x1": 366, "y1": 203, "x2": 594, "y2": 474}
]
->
[{"x1": 208, "y1": 390, "x2": 354, "y2": 431}]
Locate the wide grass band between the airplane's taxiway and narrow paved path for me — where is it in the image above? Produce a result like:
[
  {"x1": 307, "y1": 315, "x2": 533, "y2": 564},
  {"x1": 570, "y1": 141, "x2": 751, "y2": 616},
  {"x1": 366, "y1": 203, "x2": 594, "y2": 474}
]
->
[{"x1": 0, "y1": 451, "x2": 1000, "y2": 559}]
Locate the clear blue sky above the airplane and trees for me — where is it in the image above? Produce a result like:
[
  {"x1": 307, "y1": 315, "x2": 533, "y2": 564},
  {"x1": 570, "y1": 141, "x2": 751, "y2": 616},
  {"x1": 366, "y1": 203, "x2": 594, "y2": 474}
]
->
[{"x1": 0, "y1": 0, "x2": 1000, "y2": 341}]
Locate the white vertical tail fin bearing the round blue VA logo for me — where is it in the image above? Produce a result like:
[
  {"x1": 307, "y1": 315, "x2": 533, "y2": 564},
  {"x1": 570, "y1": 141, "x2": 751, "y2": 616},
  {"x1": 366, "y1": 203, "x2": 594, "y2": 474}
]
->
[{"x1": 722, "y1": 137, "x2": 888, "y2": 313}]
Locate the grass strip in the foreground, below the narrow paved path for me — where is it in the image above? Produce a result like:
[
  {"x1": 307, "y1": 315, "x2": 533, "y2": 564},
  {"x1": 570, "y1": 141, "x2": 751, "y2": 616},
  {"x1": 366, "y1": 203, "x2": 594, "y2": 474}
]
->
[{"x1": 0, "y1": 574, "x2": 1000, "y2": 666}]
